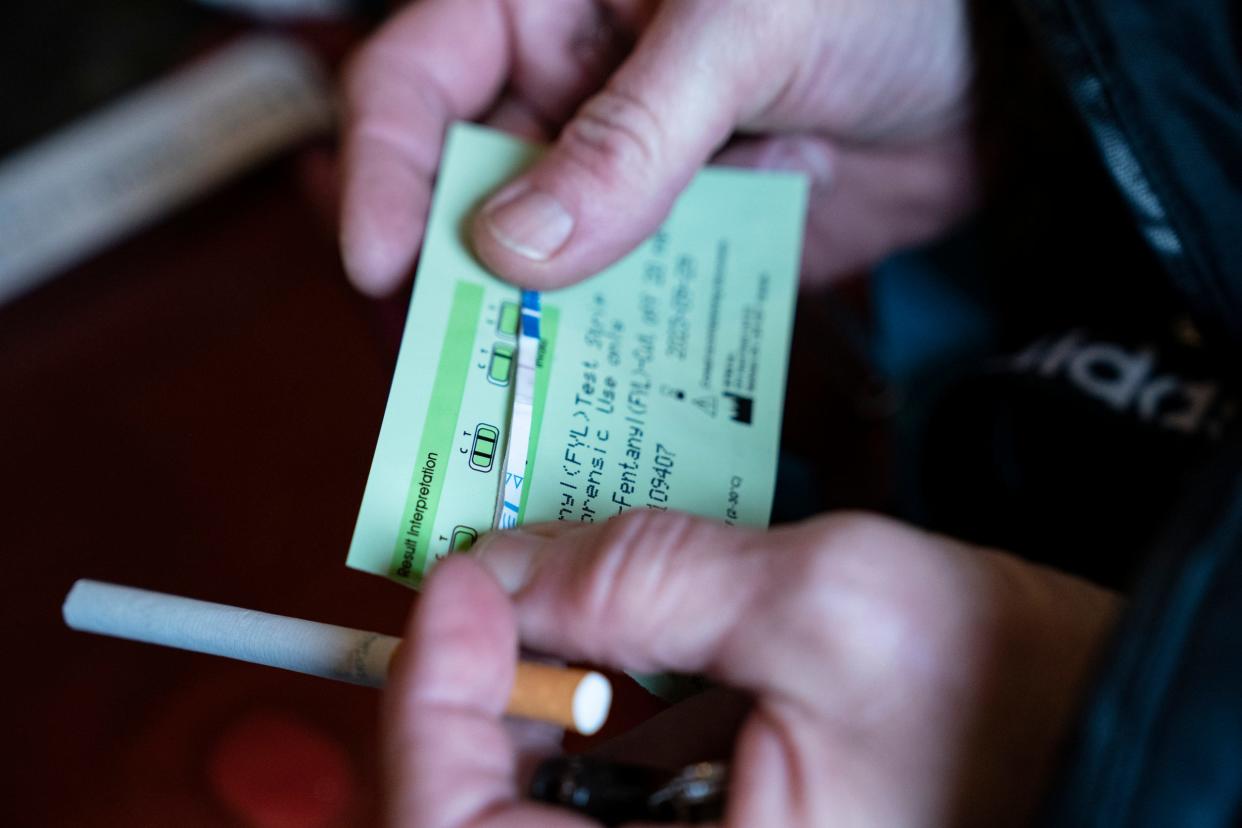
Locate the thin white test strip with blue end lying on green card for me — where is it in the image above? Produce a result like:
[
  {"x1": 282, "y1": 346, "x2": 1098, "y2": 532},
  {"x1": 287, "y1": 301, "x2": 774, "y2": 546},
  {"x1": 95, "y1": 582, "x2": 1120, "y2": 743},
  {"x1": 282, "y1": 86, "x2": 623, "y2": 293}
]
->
[{"x1": 493, "y1": 290, "x2": 543, "y2": 529}]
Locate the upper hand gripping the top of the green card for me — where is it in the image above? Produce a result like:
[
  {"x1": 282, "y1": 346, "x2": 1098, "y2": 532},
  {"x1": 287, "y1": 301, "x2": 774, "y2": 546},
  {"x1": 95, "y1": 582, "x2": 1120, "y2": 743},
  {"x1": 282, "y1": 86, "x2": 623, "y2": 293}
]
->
[{"x1": 340, "y1": 0, "x2": 976, "y2": 294}]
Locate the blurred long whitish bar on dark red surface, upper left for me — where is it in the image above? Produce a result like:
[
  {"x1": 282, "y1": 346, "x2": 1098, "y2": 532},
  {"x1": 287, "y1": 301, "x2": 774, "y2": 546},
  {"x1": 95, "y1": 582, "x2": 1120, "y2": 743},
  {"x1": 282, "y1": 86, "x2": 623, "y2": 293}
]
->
[{"x1": 0, "y1": 37, "x2": 333, "y2": 302}]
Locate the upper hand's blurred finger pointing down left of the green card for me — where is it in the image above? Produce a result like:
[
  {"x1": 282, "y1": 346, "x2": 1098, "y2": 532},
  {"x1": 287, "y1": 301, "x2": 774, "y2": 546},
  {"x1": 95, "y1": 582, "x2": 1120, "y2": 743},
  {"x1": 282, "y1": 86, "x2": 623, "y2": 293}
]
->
[{"x1": 340, "y1": 0, "x2": 512, "y2": 294}]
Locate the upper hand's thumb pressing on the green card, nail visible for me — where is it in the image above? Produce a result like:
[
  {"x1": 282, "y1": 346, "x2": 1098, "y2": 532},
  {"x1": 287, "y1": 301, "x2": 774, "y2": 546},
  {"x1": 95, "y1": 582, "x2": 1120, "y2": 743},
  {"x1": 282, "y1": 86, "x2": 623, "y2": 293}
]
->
[{"x1": 473, "y1": 0, "x2": 780, "y2": 289}]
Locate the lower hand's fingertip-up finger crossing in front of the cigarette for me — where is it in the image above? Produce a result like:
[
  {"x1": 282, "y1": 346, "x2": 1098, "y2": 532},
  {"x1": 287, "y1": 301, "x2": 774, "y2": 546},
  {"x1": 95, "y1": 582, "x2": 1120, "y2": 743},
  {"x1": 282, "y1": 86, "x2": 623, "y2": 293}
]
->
[{"x1": 384, "y1": 557, "x2": 592, "y2": 828}]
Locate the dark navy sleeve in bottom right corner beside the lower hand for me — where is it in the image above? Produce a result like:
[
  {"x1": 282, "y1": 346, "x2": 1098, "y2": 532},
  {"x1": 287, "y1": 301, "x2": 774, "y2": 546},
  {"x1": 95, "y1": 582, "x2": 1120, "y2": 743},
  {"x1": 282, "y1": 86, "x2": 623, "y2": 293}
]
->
[{"x1": 1041, "y1": 447, "x2": 1242, "y2": 828}]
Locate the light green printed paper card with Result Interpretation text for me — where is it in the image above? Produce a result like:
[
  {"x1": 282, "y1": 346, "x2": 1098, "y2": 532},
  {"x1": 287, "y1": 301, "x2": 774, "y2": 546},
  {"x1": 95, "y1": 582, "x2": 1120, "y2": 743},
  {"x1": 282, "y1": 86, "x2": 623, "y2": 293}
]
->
[{"x1": 348, "y1": 124, "x2": 806, "y2": 587}]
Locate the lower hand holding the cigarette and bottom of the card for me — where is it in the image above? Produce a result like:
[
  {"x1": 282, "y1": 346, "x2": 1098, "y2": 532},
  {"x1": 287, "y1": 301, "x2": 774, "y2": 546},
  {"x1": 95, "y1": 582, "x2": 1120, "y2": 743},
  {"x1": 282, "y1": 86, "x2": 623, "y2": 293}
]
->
[{"x1": 384, "y1": 511, "x2": 1118, "y2": 828}]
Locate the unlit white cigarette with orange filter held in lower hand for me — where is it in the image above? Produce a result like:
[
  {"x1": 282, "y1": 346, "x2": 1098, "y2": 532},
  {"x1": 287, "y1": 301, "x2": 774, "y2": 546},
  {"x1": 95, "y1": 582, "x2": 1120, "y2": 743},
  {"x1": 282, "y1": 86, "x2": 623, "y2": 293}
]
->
[{"x1": 62, "y1": 580, "x2": 612, "y2": 736}]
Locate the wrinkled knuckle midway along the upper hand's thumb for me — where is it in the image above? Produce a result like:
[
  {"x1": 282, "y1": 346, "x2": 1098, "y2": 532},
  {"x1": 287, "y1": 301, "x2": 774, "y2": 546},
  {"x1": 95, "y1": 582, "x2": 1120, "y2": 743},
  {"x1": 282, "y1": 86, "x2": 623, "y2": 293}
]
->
[{"x1": 561, "y1": 87, "x2": 663, "y2": 184}]
